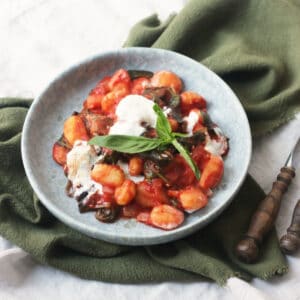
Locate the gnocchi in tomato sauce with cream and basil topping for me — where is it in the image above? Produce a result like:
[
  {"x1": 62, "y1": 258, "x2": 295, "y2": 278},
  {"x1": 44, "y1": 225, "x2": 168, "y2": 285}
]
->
[{"x1": 52, "y1": 69, "x2": 229, "y2": 230}]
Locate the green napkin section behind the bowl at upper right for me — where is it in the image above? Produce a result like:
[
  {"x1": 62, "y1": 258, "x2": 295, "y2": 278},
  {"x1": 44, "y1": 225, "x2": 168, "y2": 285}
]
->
[{"x1": 125, "y1": 0, "x2": 300, "y2": 136}]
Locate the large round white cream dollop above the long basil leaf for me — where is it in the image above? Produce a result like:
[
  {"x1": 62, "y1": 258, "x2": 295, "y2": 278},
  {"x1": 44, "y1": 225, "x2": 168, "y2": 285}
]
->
[{"x1": 109, "y1": 95, "x2": 157, "y2": 136}]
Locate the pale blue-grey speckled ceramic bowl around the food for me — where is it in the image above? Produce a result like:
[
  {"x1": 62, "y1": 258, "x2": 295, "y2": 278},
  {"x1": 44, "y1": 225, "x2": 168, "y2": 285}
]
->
[{"x1": 22, "y1": 48, "x2": 251, "y2": 245}]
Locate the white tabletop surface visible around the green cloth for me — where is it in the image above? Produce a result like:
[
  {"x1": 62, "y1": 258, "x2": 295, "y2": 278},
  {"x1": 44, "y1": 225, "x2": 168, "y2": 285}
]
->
[{"x1": 0, "y1": 0, "x2": 300, "y2": 300}]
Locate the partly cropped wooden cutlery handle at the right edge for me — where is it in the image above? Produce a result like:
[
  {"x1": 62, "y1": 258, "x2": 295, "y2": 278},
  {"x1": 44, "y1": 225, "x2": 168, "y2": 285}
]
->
[{"x1": 280, "y1": 200, "x2": 300, "y2": 254}]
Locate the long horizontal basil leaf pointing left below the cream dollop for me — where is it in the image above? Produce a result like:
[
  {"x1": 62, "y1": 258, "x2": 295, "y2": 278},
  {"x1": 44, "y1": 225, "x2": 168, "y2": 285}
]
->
[{"x1": 88, "y1": 135, "x2": 162, "y2": 153}]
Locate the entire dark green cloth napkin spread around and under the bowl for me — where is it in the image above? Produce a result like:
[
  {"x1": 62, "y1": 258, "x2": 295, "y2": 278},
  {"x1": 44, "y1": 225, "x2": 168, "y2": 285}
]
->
[{"x1": 0, "y1": 0, "x2": 300, "y2": 284}]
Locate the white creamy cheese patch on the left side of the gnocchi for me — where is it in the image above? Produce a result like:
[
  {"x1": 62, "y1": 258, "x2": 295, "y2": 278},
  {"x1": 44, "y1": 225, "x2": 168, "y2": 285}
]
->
[{"x1": 67, "y1": 141, "x2": 102, "y2": 197}]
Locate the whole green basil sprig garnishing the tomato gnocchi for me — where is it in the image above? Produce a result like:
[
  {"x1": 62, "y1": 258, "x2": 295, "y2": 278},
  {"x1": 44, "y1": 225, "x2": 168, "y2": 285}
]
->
[{"x1": 89, "y1": 103, "x2": 200, "y2": 180}]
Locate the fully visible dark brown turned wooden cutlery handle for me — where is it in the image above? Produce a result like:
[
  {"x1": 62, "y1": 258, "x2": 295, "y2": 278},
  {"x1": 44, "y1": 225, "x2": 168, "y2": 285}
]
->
[{"x1": 236, "y1": 167, "x2": 295, "y2": 263}]
